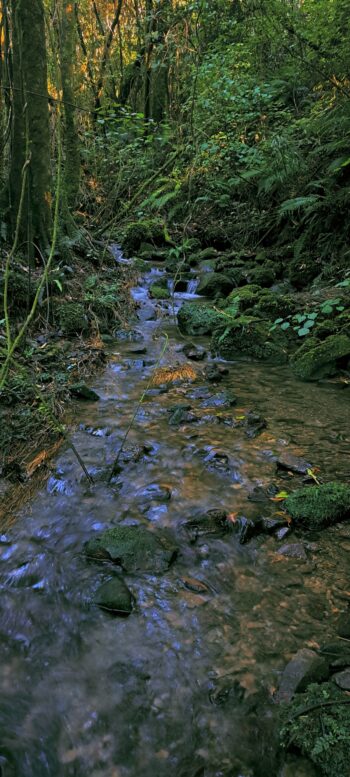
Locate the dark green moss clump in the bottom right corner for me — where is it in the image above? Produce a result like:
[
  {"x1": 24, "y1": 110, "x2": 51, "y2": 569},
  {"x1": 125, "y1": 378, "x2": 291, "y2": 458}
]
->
[{"x1": 280, "y1": 683, "x2": 350, "y2": 777}]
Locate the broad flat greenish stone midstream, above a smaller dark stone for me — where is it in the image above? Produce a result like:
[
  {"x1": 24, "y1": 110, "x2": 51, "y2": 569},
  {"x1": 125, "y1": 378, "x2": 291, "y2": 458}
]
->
[{"x1": 85, "y1": 526, "x2": 177, "y2": 572}]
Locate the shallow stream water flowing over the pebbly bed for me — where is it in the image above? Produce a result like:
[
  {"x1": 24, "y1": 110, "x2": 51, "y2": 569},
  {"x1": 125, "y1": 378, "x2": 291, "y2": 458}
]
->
[{"x1": 0, "y1": 260, "x2": 350, "y2": 777}]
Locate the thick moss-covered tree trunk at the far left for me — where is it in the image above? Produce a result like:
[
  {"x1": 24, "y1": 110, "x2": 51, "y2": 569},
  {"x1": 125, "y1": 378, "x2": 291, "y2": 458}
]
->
[{"x1": 9, "y1": 0, "x2": 51, "y2": 255}]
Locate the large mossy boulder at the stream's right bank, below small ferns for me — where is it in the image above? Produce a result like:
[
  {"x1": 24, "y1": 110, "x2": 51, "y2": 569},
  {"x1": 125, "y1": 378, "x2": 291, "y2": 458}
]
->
[{"x1": 211, "y1": 316, "x2": 288, "y2": 364}]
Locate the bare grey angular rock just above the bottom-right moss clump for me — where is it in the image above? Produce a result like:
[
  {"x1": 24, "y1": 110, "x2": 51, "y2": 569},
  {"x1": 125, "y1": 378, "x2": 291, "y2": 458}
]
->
[{"x1": 276, "y1": 648, "x2": 329, "y2": 703}]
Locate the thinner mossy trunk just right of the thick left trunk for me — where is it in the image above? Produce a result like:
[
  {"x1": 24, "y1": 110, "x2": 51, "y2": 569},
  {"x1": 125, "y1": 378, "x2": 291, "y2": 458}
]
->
[{"x1": 60, "y1": 2, "x2": 80, "y2": 208}]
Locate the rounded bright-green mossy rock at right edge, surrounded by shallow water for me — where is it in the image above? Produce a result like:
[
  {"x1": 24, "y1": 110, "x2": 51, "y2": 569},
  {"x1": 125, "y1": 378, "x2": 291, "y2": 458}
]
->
[{"x1": 284, "y1": 483, "x2": 350, "y2": 529}]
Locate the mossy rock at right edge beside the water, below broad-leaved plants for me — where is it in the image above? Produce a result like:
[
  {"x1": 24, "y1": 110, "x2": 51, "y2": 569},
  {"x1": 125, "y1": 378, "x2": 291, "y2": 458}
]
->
[{"x1": 292, "y1": 334, "x2": 350, "y2": 380}]
